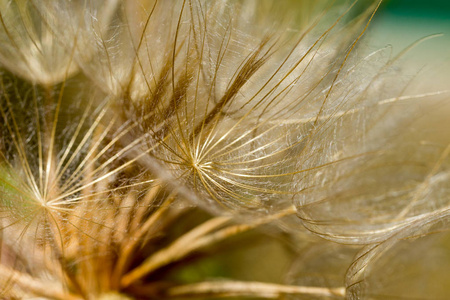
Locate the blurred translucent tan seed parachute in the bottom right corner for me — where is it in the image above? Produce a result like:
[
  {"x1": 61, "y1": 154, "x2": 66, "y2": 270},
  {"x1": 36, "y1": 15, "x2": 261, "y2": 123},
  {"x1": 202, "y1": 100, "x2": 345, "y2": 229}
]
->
[{"x1": 346, "y1": 203, "x2": 450, "y2": 299}]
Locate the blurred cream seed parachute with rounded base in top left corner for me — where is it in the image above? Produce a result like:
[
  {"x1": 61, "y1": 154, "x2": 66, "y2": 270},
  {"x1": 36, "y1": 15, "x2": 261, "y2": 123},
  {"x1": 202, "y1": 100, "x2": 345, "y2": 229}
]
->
[{"x1": 0, "y1": 0, "x2": 117, "y2": 86}]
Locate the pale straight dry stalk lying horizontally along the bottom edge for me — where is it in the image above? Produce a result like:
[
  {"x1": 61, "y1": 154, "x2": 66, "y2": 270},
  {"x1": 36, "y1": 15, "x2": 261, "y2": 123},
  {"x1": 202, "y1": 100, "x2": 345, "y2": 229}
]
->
[{"x1": 166, "y1": 281, "x2": 345, "y2": 299}]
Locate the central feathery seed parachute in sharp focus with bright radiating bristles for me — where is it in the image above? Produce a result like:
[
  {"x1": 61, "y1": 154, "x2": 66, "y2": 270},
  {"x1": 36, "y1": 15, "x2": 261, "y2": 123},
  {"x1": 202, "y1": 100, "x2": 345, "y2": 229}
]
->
[{"x1": 79, "y1": 1, "x2": 406, "y2": 217}]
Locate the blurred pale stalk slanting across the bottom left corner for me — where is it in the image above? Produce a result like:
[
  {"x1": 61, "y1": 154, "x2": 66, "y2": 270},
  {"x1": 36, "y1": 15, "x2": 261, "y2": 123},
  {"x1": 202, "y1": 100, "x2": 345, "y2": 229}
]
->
[{"x1": 0, "y1": 265, "x2": 82, "y2": 300}]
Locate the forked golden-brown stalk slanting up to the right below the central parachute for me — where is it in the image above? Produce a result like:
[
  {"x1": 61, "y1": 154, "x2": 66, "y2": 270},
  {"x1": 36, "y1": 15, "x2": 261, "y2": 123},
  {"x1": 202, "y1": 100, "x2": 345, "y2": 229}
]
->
[{"x1": 121, "y1": 207, "x2": 296, "y2": 288}]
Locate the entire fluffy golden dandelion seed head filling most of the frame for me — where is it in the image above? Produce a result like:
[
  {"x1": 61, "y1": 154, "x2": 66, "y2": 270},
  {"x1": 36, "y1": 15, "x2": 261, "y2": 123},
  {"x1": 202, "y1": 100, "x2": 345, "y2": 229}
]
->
[{"x1": 0, "y1": 0, "x2": 450, "y2": 300}]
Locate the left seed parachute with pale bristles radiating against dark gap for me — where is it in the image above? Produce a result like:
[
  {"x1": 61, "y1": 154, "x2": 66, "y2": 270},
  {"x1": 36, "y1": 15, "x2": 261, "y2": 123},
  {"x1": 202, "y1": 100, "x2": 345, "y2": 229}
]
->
[{"x1": 0, "y1": 70, "x2": 152, "y2": 299}]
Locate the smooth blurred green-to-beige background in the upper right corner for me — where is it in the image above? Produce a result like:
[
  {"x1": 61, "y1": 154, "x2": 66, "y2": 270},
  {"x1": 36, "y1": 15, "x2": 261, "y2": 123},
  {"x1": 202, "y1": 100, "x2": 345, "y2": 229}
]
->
[{"x1": 368, "y1": 0, "x2": 450, "y2": 143}]
